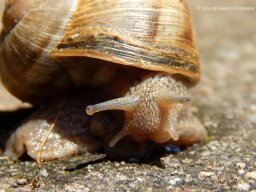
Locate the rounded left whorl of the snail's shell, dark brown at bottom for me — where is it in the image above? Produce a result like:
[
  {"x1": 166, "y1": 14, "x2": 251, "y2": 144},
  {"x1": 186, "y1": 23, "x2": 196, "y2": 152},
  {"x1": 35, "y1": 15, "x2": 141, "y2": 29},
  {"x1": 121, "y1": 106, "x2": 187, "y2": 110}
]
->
[{"x1": 0, "y1": 0, "x2": 79, "y2": 103}]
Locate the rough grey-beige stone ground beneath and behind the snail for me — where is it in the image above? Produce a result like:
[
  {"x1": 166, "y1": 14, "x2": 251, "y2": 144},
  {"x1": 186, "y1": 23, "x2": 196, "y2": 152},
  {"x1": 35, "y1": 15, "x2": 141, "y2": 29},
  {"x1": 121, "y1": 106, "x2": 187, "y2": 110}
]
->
[{"x1": 0, "y1": 0, "x2": 256, "y2": 192}]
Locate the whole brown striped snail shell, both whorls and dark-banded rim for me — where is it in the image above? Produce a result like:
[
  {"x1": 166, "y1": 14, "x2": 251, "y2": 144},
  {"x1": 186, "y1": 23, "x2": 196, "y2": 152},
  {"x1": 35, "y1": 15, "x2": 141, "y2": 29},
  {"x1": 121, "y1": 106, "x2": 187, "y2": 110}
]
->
[{"x1": 0, "y1": 0, "x2": 199, "y2": 103}]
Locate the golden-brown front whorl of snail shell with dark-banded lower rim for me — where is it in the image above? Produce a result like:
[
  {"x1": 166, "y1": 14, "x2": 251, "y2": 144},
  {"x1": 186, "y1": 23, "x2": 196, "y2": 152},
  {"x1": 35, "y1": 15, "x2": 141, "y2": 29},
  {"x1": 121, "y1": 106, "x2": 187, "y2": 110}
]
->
[{"x1": 53, "y1": 0, "x2": 199, "y2": 84}]
